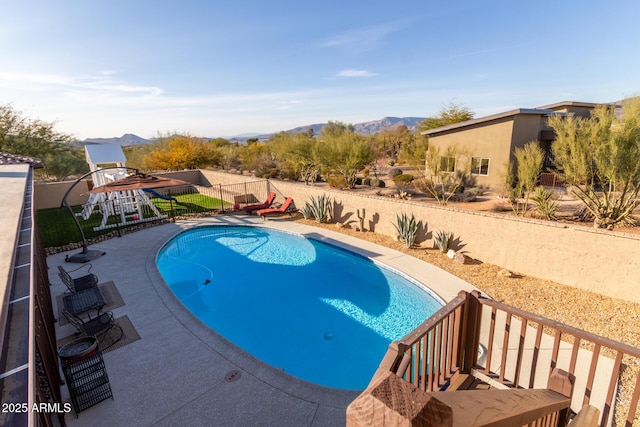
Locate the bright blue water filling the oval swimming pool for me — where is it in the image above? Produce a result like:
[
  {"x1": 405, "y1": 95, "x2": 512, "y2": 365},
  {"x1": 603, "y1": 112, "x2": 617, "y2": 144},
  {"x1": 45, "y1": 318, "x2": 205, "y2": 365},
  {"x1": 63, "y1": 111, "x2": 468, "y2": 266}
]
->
[{"x1": 157, "y1": 226, "x2": 442, "y2": 390}]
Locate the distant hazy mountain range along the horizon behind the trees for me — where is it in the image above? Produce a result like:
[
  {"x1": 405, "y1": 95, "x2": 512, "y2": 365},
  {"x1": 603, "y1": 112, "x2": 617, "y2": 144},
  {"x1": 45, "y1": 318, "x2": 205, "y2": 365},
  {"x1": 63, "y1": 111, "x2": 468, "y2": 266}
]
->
[{"x1": 79, "y1": 117, "x2": 424, "y2": 147}]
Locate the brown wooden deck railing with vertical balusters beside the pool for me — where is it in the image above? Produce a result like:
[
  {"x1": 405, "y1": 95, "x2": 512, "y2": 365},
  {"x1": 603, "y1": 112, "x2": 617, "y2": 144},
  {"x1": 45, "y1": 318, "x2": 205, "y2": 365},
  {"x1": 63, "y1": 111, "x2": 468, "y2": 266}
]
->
[{"x1": 372, "y1": 292, "x2": 640, "y2": 427}]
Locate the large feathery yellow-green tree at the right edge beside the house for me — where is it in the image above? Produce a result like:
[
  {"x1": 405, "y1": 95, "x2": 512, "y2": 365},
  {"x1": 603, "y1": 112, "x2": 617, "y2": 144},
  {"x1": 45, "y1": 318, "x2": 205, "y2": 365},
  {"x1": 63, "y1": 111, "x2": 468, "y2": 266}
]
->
[{"x1": 548, "y1": 97, "x2": 640, "y2": 229}]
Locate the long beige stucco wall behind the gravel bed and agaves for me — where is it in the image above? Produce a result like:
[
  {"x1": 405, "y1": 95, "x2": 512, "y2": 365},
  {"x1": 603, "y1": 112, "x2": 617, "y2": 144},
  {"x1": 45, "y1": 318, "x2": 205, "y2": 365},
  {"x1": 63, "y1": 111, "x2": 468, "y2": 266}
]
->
[{"x1": 203, "y1": 171, "x2": 640, "y2": 303}]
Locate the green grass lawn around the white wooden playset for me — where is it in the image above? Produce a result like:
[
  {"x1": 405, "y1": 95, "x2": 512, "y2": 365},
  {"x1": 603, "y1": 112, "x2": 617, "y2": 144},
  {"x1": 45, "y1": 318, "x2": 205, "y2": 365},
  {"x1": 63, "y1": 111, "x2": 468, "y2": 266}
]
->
[{"x1": 36, "y1": 193, "x2": 231, "y2": 248}]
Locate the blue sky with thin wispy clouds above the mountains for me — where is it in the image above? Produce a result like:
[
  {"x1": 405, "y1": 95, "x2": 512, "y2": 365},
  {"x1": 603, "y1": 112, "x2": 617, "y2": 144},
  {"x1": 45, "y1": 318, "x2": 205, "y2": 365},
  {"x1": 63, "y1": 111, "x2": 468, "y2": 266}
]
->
[{"x1": 0, "y1": 0, "x2": 640, "y2": 139}]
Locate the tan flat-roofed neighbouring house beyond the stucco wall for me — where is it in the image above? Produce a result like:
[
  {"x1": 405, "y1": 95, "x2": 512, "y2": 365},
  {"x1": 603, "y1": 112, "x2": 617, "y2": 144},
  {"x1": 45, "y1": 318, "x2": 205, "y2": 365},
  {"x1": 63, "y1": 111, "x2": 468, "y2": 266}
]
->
[{"x1": 422, "y1": 101, "x2": 598, "y2": 189}]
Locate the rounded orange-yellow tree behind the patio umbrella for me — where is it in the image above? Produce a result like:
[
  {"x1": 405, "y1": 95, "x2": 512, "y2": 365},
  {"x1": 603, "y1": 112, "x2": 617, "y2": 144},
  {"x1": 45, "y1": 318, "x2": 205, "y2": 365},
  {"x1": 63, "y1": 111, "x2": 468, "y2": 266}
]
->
[{"x1": 145, "y1": 135, "x2": 221, "y2": 170}]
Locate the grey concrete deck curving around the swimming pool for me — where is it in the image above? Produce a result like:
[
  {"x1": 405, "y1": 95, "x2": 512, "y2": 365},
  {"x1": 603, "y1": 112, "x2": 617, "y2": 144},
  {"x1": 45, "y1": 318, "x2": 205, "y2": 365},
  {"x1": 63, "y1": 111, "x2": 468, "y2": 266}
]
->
[{"x1": 47, "y1": 216, "x2": 475, "y2": 427}]
